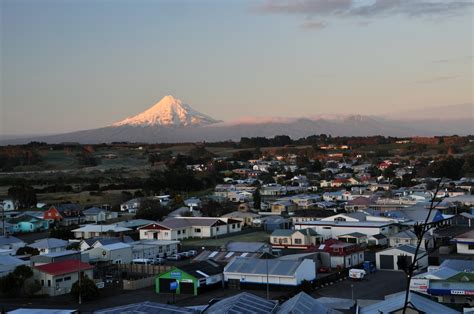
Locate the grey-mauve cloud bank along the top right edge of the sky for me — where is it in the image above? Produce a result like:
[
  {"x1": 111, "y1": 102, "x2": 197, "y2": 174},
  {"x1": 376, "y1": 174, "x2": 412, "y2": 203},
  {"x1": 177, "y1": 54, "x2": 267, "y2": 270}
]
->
[{"x1": 257, "y1": 0, "x2": 474, "y2": 29}]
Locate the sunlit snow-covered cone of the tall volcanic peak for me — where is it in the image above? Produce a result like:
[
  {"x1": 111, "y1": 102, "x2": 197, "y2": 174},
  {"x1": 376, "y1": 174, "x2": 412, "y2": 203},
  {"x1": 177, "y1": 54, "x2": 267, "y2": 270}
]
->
[{"x1": 112, "y1": 95, "x2": 219, "y2": 127}]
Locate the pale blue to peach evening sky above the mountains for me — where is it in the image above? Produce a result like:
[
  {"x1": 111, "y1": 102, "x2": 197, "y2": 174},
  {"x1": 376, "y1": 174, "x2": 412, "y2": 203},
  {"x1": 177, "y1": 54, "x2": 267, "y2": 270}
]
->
[{"x1": 0, "y1": 0, "x2": 474, "y2": 135}]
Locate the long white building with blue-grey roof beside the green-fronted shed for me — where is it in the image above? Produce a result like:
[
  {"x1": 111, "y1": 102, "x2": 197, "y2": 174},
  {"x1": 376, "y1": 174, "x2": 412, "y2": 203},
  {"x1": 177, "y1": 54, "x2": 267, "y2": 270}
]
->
[{"x1": 224, "y1": 257, "x2": 316, "y2": 287}]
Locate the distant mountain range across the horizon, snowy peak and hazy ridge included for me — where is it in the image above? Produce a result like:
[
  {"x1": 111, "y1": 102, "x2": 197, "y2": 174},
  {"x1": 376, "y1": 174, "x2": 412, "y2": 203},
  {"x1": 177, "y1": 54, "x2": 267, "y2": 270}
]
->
[{"x1": 0, "y1": 95, "x2": 474, "y2": 145}]
